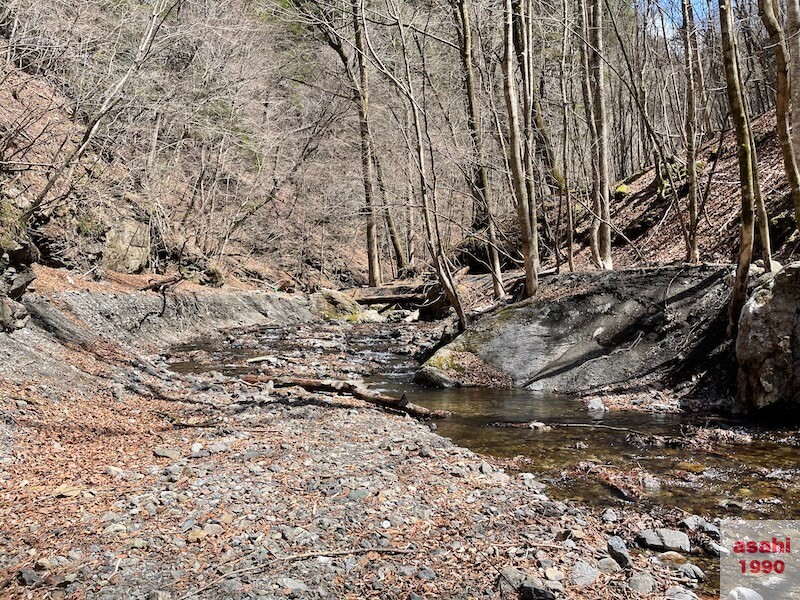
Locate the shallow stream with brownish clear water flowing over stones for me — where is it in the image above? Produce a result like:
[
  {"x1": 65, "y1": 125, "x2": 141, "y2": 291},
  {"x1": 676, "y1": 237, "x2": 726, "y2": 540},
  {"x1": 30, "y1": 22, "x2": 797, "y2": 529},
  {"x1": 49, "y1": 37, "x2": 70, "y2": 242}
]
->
[{"x1": 170, "y1": 324, "x2": 800, "y2": 519}]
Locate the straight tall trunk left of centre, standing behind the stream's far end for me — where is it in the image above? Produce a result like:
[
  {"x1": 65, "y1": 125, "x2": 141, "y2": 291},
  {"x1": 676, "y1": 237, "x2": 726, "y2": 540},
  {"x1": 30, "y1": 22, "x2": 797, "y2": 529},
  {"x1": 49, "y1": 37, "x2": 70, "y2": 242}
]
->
[{"x1": 350, "y1": 0, "x2": 381, "y2": 287}]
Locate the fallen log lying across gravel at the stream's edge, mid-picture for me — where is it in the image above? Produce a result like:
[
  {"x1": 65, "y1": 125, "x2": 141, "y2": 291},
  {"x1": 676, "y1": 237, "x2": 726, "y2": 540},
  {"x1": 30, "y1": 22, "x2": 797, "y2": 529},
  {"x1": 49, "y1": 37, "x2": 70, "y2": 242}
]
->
[{"x1": 241, "y1": 375, "x2": 451, "y2": 419}]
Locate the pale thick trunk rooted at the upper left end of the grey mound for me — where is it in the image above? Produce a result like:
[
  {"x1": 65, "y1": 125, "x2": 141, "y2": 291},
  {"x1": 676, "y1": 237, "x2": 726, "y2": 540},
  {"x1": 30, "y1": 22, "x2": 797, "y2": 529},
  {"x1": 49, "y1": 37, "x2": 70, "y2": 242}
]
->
[{"x1": 503, "y1": 0, "x2": 539, "y2": 297}]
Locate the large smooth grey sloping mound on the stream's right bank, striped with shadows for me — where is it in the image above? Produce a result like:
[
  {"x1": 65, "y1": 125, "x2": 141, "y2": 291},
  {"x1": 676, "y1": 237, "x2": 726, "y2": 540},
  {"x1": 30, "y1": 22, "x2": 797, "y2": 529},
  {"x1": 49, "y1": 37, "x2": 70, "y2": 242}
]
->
[{"x1": 422, "y1": 267, "x2": 729, "y2": 393}]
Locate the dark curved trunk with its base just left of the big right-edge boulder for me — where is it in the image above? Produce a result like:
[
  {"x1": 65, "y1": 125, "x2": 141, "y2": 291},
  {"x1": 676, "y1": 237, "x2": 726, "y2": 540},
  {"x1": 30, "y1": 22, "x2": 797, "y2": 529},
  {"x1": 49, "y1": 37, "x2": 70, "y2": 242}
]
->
[{"x1": 719, "y1": 0, "x2": 755, "y2": 339}]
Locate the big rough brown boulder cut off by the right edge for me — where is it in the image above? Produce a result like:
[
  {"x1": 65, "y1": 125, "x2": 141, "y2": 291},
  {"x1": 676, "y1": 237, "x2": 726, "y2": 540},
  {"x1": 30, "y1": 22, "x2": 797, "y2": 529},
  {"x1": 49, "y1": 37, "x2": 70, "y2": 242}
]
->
[{"x1": 736, "y1": 262, "x2": 800, "y2": 410}]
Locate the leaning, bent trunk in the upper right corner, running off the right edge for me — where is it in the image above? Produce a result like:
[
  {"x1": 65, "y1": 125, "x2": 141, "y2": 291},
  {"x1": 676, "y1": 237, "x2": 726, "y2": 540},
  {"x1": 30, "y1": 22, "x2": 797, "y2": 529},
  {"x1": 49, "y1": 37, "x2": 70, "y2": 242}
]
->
[{"x1": 758, "y1": 0, "x2": 800, "y2": 232}]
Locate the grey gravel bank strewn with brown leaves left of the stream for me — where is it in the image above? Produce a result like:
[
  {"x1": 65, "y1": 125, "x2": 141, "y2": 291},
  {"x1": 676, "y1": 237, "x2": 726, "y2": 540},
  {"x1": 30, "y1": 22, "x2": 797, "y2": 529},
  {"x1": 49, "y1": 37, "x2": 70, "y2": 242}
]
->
[{"x1": 0, "y1": 270, "x2": 713, "y2": 599}]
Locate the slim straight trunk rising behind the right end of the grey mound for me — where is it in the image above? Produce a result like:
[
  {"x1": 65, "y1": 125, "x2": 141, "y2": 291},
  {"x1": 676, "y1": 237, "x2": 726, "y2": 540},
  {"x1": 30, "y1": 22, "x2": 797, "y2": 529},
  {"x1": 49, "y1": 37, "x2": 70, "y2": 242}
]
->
[{"x1": 681, "y1": 0, "x2": 700, "y2": 264}]
